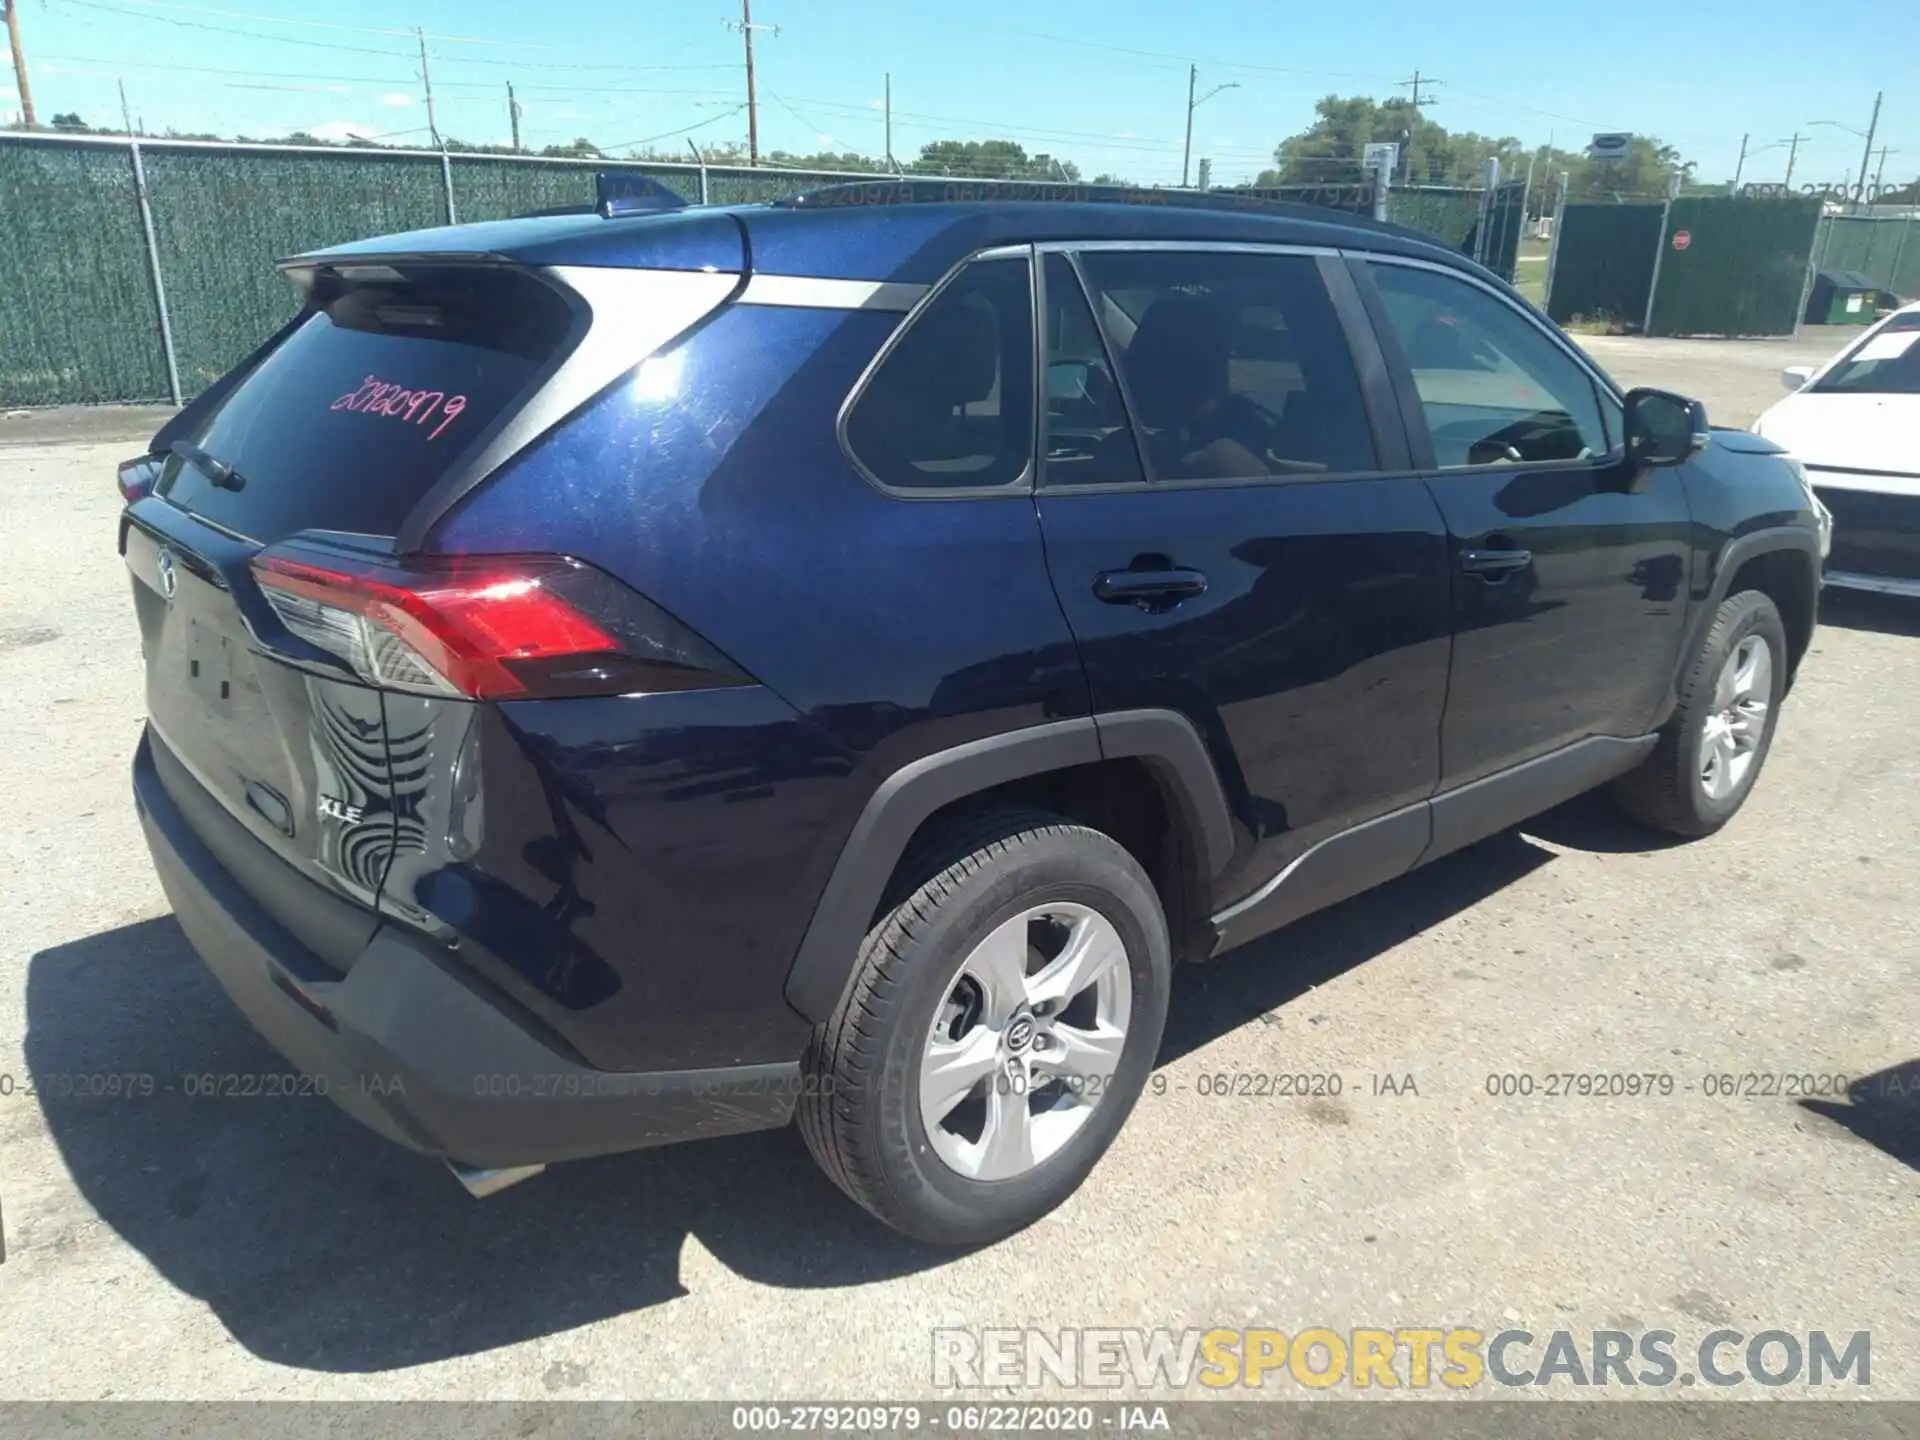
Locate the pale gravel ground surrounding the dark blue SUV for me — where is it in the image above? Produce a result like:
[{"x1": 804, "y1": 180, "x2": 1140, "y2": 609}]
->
[{"x1": 0, "y1": 389, "x2": 1920, "y2": 1400}]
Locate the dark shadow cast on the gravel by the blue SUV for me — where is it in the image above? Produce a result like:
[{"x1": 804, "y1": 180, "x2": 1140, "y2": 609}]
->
[{"x1": 27, "y1": 831, "x2": 1553, "y2": 1373}]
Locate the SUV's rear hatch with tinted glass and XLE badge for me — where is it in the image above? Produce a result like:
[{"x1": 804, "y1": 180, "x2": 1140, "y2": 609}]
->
[{"x1": 121, "y1": 261, "x2": 588, "y2": 970}]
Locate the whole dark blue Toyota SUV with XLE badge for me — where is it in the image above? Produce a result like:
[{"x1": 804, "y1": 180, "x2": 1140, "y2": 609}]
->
[{"x1": 121, "y1": 184, "x2": 1824, "y2": 1242}]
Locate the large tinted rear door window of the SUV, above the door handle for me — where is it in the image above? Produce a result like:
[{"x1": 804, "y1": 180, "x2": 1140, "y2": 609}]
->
[{"x1": 1079, "y1": 250, "x2": 1379, "y2": 480}]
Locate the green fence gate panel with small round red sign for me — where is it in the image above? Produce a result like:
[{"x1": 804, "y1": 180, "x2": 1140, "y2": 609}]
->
[{"x1": 1643, "y1": 196, "x2": 1820, "y2": 336}]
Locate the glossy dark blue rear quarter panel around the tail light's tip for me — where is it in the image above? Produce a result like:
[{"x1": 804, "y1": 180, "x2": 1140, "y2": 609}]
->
[{"x1": 417, "y1": 305, "x2": 1089, "y2": 1064}]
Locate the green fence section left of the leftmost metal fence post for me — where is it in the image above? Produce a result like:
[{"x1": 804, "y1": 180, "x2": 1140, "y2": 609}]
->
[{"x1": 0, "y1": 142, "x2": 167, "y2": 407}]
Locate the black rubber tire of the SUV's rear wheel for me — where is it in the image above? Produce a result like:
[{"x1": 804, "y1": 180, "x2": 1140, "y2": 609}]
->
[{"x1": 799, "y1": 810, "x2": 1173, "y2": 1246}]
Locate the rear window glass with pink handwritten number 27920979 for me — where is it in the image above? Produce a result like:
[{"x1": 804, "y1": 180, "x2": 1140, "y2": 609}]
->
[{"x1": 159, "y1": 267, "x2": 572, "y2": 541}]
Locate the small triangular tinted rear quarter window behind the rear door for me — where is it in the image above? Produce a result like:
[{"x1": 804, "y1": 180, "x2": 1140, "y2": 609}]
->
[{"x1": 847, "y1": 257, "x2": 1033, "y2": 492}]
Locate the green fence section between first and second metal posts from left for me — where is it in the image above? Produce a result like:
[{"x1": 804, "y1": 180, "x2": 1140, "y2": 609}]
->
[{"x1": 142, "y1": 146, "x2": 445, "y2": 396}]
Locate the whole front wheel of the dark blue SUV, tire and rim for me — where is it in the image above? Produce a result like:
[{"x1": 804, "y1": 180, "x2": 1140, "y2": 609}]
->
[{"x1": 1615, "y1": 589, "x2": 1788, "y2": 839}]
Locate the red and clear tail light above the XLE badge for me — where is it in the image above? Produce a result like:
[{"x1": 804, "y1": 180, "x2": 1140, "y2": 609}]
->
[{"x1": 253, "y1": 551, "x2": 749, "y2": 701}]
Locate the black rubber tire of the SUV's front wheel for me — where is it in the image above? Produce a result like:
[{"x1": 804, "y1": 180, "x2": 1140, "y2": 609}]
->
[{"x1": 1613, "y1": 589, "x2": 1789, "y2": 839}]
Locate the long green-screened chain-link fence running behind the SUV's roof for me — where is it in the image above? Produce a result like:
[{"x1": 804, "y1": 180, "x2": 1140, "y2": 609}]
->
[{"x1": 0, "y1": 134, "x2": 1511, "y2": 407}]
